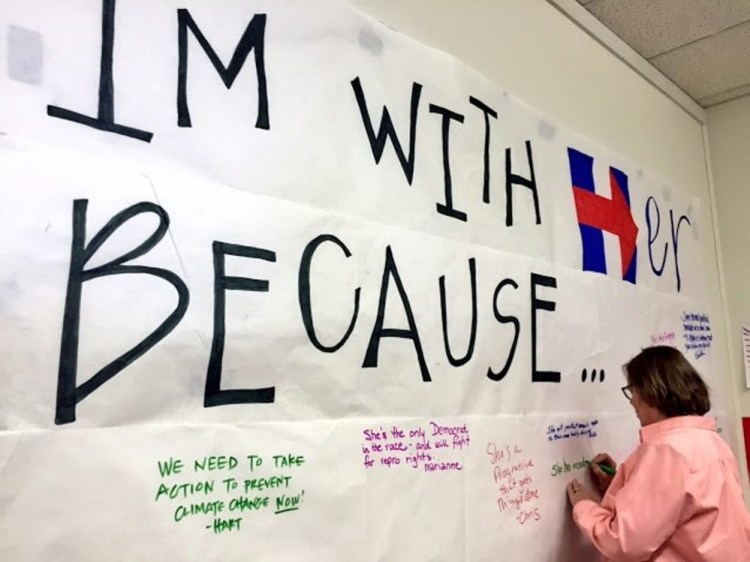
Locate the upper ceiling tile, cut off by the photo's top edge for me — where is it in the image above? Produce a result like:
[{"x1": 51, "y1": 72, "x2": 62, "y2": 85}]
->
[{"x1": 585, "y1": 0, "x2": 750, "y2": 59}]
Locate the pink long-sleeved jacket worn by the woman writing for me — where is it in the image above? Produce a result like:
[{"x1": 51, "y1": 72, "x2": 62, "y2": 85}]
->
[{"x1": 573, "y1": 416, "x2": 750, "y2": 562}]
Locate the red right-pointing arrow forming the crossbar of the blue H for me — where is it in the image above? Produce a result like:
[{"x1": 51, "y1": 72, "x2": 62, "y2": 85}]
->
[{"x1": 573, "y1": 170, "x2": 638, "y2": 277}]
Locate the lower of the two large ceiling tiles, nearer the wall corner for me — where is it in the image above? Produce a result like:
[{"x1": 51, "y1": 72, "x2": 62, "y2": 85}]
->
[{"x1": 651, "y1": 20, "x2": 750, "y2": 100}]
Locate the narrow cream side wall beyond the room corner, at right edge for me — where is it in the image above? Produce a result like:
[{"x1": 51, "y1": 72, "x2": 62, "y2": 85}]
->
[{"x1": 707, "y1": 97, "x2": 750, "y2": 416}]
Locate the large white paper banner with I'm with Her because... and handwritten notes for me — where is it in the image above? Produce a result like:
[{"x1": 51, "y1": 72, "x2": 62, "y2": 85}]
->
[{"x1": 0, "y1": 0, "x2": 736, "y2": 562}]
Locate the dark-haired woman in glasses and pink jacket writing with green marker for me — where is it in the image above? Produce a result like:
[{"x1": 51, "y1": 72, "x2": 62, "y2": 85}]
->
[{"x1": 567, "y1": 346, "x2": 750, "y2": 562}]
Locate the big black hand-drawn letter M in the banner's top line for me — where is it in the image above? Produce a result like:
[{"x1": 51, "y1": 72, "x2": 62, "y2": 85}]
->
[{"x1": 177, "y1": 8, "x2": 270, "y2": 130}]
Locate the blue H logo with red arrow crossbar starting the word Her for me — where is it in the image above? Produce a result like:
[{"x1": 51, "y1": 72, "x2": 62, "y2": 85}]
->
[{"x1": 568, "y1": 147, "x2": 638, "y2": 283}]
